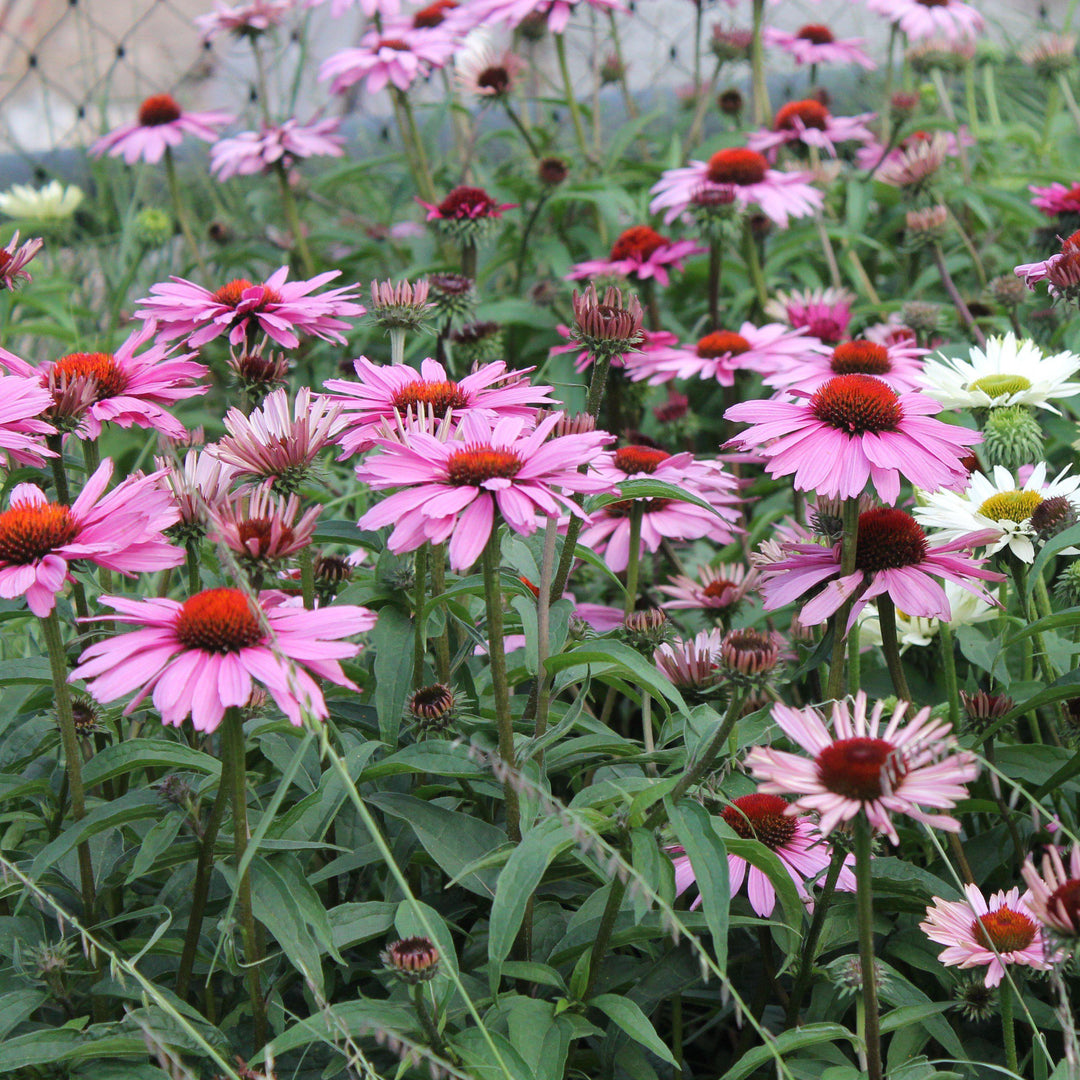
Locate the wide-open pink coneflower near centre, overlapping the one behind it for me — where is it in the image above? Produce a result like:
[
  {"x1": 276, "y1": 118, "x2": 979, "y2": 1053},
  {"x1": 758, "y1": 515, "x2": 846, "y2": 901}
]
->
[{"x1": 356, "y1": 414, "x2": 611, "y2": 570}]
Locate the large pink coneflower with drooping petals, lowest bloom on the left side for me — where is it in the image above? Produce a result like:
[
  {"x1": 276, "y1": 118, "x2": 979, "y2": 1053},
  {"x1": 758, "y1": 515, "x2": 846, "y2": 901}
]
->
[{"x1": 70, "y1": 589, "x2": 376, "y2": 732}]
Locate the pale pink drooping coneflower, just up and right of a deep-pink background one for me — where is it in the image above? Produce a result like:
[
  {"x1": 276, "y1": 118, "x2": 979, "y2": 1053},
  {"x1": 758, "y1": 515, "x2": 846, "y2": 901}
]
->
[{"x1": 649, "y1": 147, "x2": 824, "y2": 229}]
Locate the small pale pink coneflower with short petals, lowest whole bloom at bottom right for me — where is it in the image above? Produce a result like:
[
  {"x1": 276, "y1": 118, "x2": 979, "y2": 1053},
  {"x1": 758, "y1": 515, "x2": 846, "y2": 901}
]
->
[{"x1": 919, "y1": 885, "x2": 1050, "y2": 986}]
